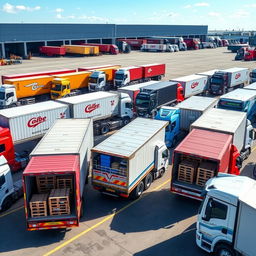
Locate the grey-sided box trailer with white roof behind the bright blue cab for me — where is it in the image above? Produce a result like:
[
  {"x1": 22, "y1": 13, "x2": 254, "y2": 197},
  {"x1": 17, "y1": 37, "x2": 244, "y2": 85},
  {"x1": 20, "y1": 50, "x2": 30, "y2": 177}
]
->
[{"x1": 176, "y1": 96, "x2": 217, "y2": 131}]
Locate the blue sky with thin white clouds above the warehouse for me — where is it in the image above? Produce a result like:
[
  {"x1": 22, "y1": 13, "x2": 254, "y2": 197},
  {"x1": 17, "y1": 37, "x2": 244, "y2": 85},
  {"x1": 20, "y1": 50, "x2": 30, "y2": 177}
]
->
[{"x1": 0, "y1": 0, "x2": 256, "y2": 30}]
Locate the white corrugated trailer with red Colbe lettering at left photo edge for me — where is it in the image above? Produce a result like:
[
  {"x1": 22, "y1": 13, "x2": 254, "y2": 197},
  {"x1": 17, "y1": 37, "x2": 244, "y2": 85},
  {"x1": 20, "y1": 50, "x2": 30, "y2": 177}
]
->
[{"x1": 0, "y1": 101, "x2": 70, "y2": 144}]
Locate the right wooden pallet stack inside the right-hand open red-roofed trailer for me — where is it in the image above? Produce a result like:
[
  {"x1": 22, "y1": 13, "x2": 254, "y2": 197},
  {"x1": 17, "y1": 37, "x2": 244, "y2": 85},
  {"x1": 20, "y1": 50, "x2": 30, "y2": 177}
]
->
[{"x1": 196, "y1": 162, "x2": 216, "y2": 186}]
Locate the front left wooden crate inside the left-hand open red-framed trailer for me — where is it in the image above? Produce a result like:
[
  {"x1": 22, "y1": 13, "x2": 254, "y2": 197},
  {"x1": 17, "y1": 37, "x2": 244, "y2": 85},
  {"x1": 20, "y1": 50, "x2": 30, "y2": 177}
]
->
[{"x1": 29, "y1": 194, "x2": 48, "y2": 218}]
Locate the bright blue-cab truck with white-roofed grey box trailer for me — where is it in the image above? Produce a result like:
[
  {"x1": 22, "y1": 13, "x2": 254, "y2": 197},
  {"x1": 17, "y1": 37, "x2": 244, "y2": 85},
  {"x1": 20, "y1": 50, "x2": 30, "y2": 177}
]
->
[{"x1": 155, "y1": 96, "x2": 217, "y2": 147}]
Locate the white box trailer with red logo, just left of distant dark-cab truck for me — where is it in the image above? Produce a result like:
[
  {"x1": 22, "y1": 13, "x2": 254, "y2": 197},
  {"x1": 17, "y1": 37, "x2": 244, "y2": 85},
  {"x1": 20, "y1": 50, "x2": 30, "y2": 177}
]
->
[{"x1": 170, "y1": 75, "x2": 207, "y2": 98}]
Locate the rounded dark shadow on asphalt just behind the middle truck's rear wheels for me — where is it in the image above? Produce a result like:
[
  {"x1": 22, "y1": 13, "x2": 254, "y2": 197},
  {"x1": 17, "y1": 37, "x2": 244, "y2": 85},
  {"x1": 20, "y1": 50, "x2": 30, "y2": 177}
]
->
[{"x1": 110, "y1": 189, "x2": 200, "y2": 234}]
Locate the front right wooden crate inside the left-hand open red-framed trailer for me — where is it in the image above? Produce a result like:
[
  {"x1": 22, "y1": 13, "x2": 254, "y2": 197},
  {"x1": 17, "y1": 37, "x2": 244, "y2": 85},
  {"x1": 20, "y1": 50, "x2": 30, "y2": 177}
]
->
[{"x1": 48, "y1": 188, "x2": 70, "y2": 215}]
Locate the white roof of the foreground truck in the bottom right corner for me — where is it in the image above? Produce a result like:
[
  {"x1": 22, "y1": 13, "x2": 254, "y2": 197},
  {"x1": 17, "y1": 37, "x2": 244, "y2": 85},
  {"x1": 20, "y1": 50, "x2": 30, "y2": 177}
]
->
[{"x1": 206, "y1": 175, "x2": 256, "y2": 208}]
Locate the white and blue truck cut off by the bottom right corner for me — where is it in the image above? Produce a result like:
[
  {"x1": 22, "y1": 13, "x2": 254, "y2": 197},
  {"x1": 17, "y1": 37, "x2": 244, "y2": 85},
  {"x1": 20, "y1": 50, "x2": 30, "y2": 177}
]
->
[{"x1": 196, "y1": 175, "x2": 256, "y2": 256}]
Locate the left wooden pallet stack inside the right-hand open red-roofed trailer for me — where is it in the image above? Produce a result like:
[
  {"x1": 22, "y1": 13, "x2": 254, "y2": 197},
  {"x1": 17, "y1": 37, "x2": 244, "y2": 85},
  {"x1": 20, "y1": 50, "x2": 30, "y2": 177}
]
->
[{"x1": 178, "y1": 160, "x2": 197, "y2": 183}]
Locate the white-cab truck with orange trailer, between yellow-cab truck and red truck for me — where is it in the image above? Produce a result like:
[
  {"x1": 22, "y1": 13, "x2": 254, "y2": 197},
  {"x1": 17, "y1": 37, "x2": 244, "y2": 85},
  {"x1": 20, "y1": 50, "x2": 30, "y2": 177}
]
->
[{"x1": 89, "y1": 65, "x2": 121, "y2": 92}]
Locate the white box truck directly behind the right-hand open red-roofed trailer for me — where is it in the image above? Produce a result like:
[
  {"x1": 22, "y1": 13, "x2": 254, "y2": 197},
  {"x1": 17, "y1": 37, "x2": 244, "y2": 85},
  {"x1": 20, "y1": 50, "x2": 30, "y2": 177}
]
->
[{"x1": 191, "y1": 108, "x2": 255, "y2": 162}]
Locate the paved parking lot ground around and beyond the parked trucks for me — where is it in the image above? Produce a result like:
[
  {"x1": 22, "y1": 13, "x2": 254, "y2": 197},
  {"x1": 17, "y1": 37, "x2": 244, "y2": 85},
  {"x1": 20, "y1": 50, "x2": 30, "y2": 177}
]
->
[{"x1": 0, "y1": 47, "x2": 256, "y2": 256}]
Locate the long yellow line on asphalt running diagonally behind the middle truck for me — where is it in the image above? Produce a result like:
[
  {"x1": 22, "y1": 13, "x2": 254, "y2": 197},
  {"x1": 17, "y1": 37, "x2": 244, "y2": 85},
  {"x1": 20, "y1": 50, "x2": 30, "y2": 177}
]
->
[{"x1": 43, "y1": 179, "x2": 170, "y2": 256}]
